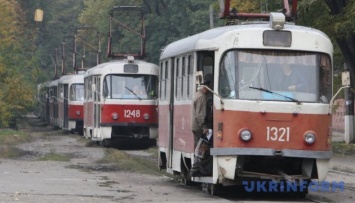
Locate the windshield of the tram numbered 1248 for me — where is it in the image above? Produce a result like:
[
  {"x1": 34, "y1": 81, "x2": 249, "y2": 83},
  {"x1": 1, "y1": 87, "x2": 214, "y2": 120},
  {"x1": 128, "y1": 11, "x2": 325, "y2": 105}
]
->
[{"x1": 103, "y1": 75, "x2": 158, "y2": 100}]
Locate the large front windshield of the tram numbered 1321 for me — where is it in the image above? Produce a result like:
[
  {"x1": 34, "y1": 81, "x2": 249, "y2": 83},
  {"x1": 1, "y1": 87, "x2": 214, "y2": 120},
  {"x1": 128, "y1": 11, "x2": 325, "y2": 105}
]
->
[{"x1": 218, "y1": 50, "x2": 332, "y2": 103}]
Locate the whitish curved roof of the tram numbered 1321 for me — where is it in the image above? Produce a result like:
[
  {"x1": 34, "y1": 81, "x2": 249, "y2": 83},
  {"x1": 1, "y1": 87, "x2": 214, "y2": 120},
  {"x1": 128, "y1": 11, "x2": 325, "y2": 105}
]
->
[{"x1": 160, "y1": 21, "x2": 333, "y2": 59}]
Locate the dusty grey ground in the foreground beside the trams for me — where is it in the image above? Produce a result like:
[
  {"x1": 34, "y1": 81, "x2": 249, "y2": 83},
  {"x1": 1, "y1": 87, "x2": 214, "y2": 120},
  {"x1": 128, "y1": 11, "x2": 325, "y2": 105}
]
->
[{"x1": 0, "y1": 118, "x2": 355, "y2": 203}]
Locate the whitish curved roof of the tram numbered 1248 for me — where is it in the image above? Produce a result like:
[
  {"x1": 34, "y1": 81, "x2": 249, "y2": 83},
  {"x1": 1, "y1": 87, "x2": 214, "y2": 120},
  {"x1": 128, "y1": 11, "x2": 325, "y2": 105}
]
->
[{"x1": 84, "y1": 59, "x2": 159, "y2": 77}]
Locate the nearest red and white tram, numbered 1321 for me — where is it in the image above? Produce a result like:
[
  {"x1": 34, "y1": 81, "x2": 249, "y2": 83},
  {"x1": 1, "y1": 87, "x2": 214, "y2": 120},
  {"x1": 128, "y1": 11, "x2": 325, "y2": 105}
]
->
[{"x1": 158, "y1": 13, "x2": 333, "y2": 193}]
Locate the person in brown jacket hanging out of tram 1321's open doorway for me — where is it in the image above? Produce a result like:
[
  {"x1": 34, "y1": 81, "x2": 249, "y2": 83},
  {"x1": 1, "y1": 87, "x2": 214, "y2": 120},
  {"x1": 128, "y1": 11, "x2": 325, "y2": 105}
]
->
[{"x1": 190, "y1": 81, "x2": 213, "y2": 177}]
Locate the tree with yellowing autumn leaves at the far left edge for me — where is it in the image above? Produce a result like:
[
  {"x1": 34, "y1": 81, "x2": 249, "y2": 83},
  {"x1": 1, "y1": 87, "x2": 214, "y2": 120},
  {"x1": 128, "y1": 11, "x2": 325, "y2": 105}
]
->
[{"x1": 0, "y1": 0, "x2": 33, "y2": 127}]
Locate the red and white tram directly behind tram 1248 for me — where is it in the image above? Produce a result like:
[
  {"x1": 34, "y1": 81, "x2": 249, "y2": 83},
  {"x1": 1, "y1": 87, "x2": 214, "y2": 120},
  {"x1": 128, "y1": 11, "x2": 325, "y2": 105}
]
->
[{"x1": 58, "y1": 73, "x2": 84, "y2": 133}]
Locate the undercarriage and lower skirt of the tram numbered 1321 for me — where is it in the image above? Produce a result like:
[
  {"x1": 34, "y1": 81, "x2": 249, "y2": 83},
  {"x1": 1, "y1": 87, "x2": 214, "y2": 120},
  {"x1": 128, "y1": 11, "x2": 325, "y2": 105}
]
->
[{"x1": 159, "y1": 148, "x2": 330, "y2": 193}]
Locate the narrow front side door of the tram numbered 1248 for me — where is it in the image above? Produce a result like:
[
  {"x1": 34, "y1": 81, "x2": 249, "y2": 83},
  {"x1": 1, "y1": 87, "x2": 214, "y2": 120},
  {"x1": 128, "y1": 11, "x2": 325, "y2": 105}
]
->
[{"x1": 93, "y1": 76, "x2": 101, "y2": 138}]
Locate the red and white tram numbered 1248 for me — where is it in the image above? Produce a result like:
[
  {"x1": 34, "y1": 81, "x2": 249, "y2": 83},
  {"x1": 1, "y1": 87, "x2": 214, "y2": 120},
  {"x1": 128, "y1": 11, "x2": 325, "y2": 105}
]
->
[{"x1": 84, "y1": 56, "x2": 158, "y2": 146}]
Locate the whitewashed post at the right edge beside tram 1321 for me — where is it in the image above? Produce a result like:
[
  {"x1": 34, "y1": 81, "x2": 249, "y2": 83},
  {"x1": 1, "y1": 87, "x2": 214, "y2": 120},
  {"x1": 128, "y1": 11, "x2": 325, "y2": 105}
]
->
[{"x1": 342, "y1": 64, "x2": 355, "y2": 144}]
